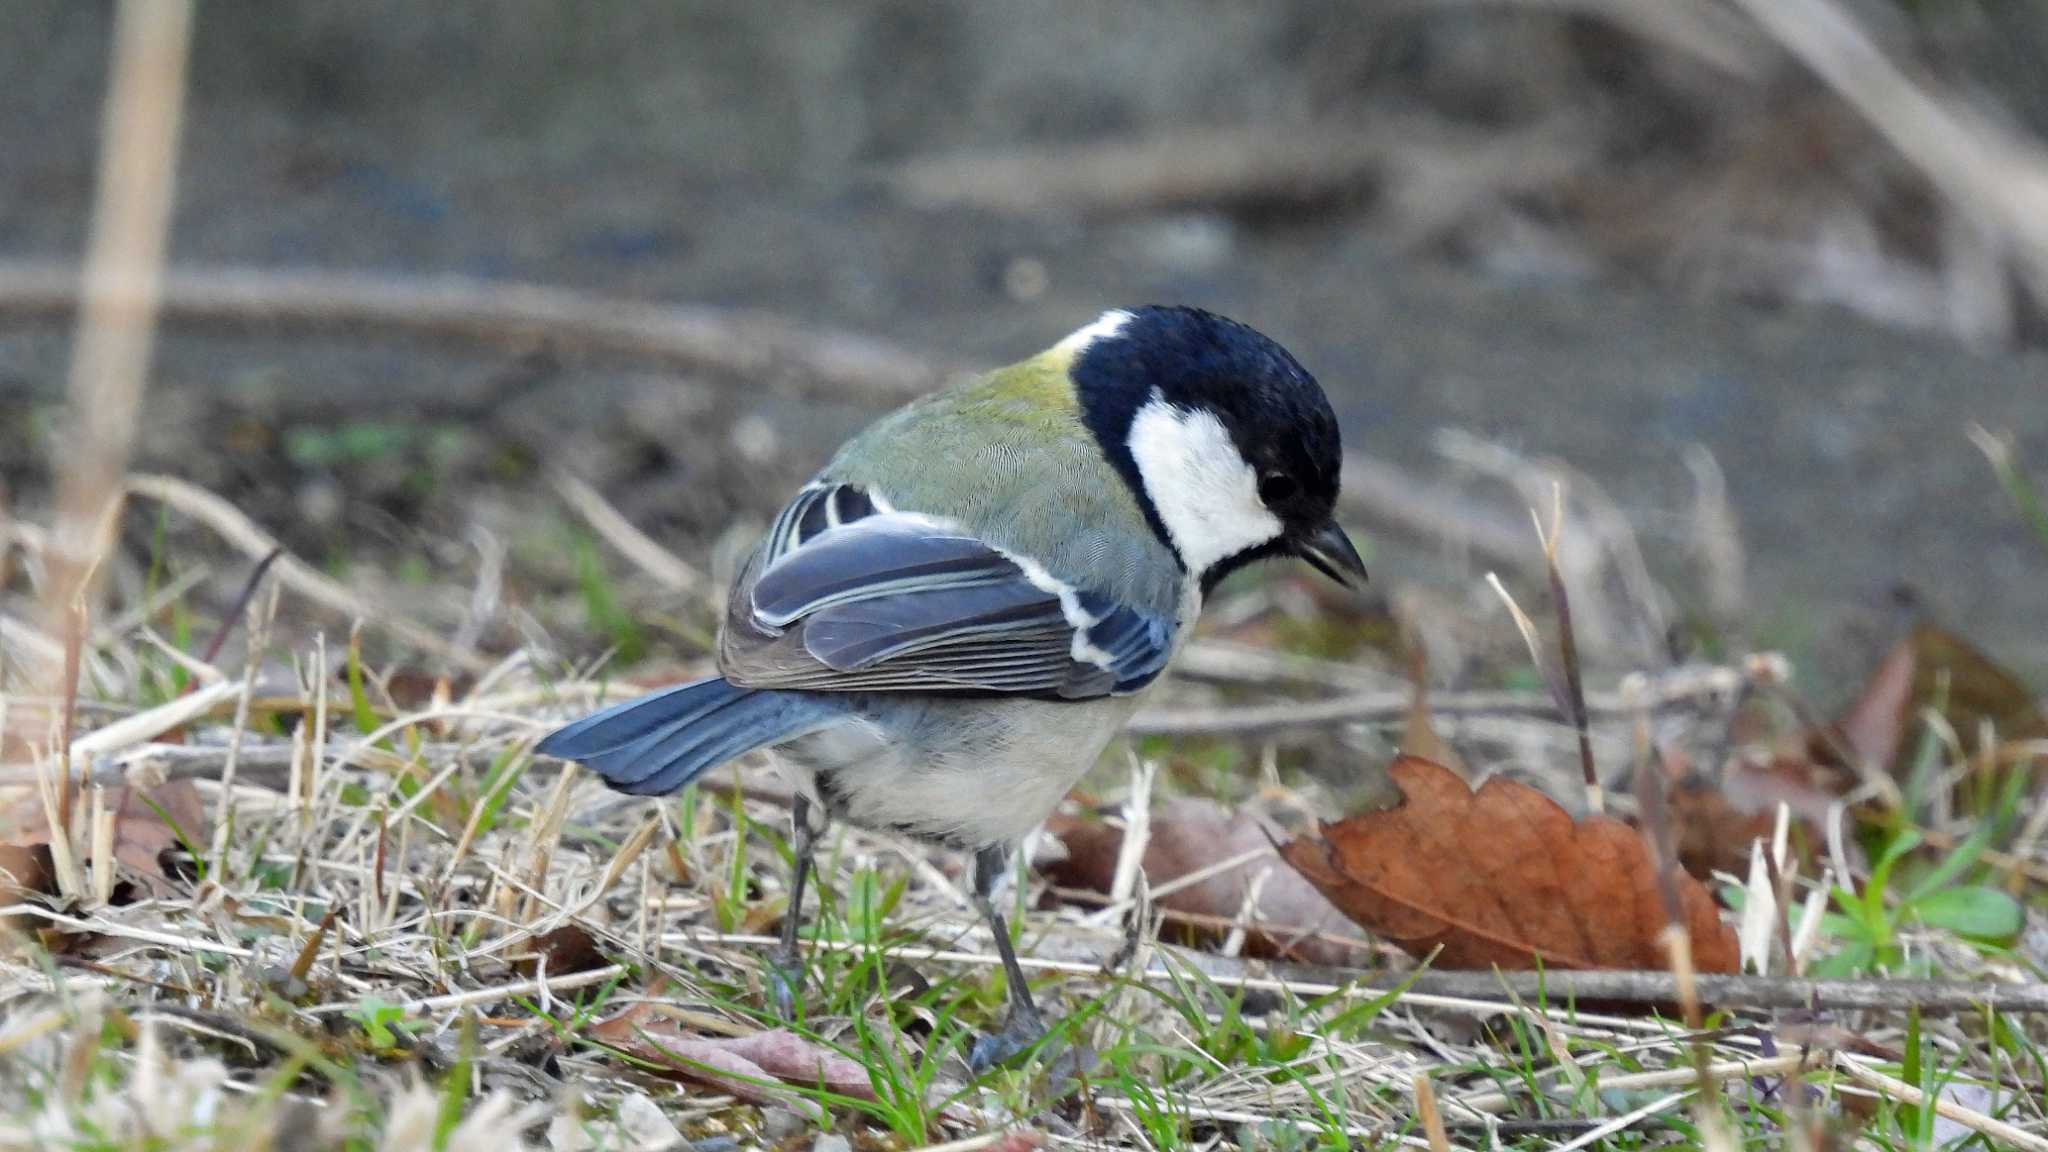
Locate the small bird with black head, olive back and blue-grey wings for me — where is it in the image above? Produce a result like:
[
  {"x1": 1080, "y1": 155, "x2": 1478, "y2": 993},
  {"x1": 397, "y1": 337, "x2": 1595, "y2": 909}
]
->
[{"x1": 537, "y1": 305, "x2": 1366, "y2": 1070}]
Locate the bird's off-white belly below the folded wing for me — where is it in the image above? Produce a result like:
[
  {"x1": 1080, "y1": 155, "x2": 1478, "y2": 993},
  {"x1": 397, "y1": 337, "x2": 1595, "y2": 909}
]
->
[{"x1": 780, "y1": 693, "x2": 1137, "y2": 849}]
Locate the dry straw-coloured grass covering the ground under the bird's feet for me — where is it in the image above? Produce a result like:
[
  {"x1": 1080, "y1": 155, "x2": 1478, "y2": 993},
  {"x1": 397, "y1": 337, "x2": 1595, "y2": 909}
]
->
[{"x1": 0, "y1": 459, "x2": 2040, "y2": 1148}]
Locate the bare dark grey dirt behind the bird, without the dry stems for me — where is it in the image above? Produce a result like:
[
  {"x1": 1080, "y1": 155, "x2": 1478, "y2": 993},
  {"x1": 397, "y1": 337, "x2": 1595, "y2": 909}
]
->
[{"x1": 0, "y1": 0, "x2": 2048, "y2": 688}]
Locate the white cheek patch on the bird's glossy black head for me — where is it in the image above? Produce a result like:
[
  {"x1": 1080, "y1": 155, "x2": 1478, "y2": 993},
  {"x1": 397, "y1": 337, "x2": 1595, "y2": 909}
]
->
[{"x1": 1126, "y1": 392, "x2": 1282, "y2": 572}]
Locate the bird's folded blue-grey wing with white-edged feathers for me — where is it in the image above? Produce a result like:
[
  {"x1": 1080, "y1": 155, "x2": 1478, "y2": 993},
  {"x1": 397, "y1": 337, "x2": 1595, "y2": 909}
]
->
[{"x1": 723, "y1": 486, "x2": 1174, "y2": 699}]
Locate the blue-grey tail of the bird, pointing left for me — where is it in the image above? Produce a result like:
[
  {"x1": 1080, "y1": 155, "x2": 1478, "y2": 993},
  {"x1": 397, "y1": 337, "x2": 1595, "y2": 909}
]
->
[{"x1": 535, "y1": 676, "x2": 844, "y2": 795}]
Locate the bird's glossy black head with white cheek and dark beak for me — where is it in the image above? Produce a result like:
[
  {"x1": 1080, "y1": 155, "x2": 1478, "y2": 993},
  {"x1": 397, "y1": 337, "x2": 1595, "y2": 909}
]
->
[{"x1": 1061, "y1": 307, "x2": 1366, "y2": 588}]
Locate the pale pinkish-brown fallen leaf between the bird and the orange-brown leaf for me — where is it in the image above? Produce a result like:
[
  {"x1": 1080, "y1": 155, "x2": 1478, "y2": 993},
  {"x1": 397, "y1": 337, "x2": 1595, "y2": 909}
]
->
[{"x1": 1044, "y1": 797, "x2": 1372, "y2": 965}]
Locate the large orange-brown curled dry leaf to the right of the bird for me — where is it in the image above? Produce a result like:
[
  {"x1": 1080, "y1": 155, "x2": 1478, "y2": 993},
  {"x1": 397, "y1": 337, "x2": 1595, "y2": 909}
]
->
[{"x1": 1280, "y1": 756, "x2": 1737, "y2": 972}]
